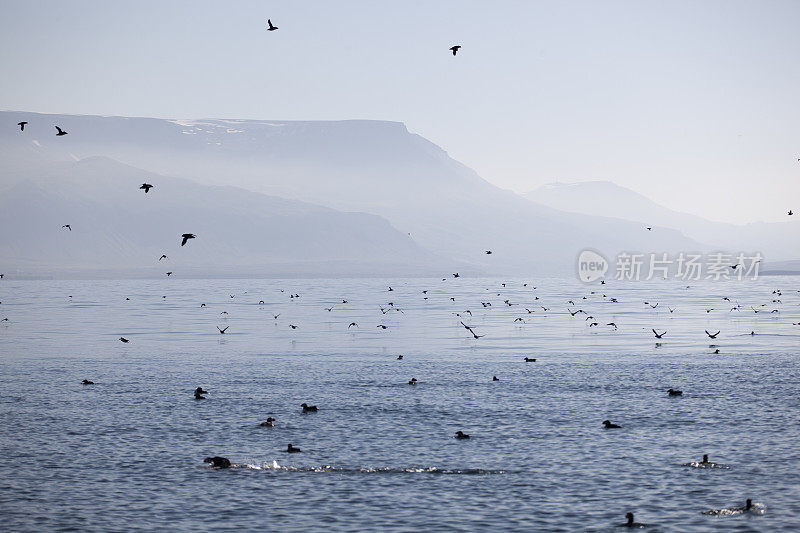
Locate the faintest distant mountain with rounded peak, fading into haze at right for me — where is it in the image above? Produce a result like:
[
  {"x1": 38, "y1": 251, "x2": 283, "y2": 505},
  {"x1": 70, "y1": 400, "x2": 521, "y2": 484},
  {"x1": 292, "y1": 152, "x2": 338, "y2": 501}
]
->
[{"x1": 524, "y1": 181, "x2": 800, "y2": 261}]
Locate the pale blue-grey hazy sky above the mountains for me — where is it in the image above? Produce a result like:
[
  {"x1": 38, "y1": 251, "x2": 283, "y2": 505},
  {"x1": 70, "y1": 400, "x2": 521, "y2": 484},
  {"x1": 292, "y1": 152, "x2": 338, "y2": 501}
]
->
[{"x1": 0, "y1": 0, "x2": 800, "y2": 222}]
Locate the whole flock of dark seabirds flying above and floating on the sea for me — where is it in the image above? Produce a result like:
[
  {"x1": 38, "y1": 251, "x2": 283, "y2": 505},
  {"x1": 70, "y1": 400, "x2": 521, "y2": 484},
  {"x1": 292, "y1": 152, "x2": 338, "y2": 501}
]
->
[{"x1": 0, "y1": 14, "x2": 800, "y2": 528}]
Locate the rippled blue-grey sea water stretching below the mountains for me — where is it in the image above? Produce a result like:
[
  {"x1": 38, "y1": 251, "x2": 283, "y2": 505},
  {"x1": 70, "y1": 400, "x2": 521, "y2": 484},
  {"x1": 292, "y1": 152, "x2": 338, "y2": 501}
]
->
[{"x1": 0, "y1": 277, "x2": 800, "y2": 531}]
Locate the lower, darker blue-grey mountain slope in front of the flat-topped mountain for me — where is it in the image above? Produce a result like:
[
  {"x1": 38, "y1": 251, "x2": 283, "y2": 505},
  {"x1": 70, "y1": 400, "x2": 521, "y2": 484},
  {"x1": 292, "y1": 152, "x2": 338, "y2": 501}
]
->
[{"x1": 0, "y1": 157, "x2": 450, "y2": 277}]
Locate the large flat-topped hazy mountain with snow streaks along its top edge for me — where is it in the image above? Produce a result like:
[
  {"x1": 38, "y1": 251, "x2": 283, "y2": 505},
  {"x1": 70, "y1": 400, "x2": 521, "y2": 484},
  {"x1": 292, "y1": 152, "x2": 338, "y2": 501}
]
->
[{"x1": 0, "y1": 112, "x2": 704, "y2": 275}]
